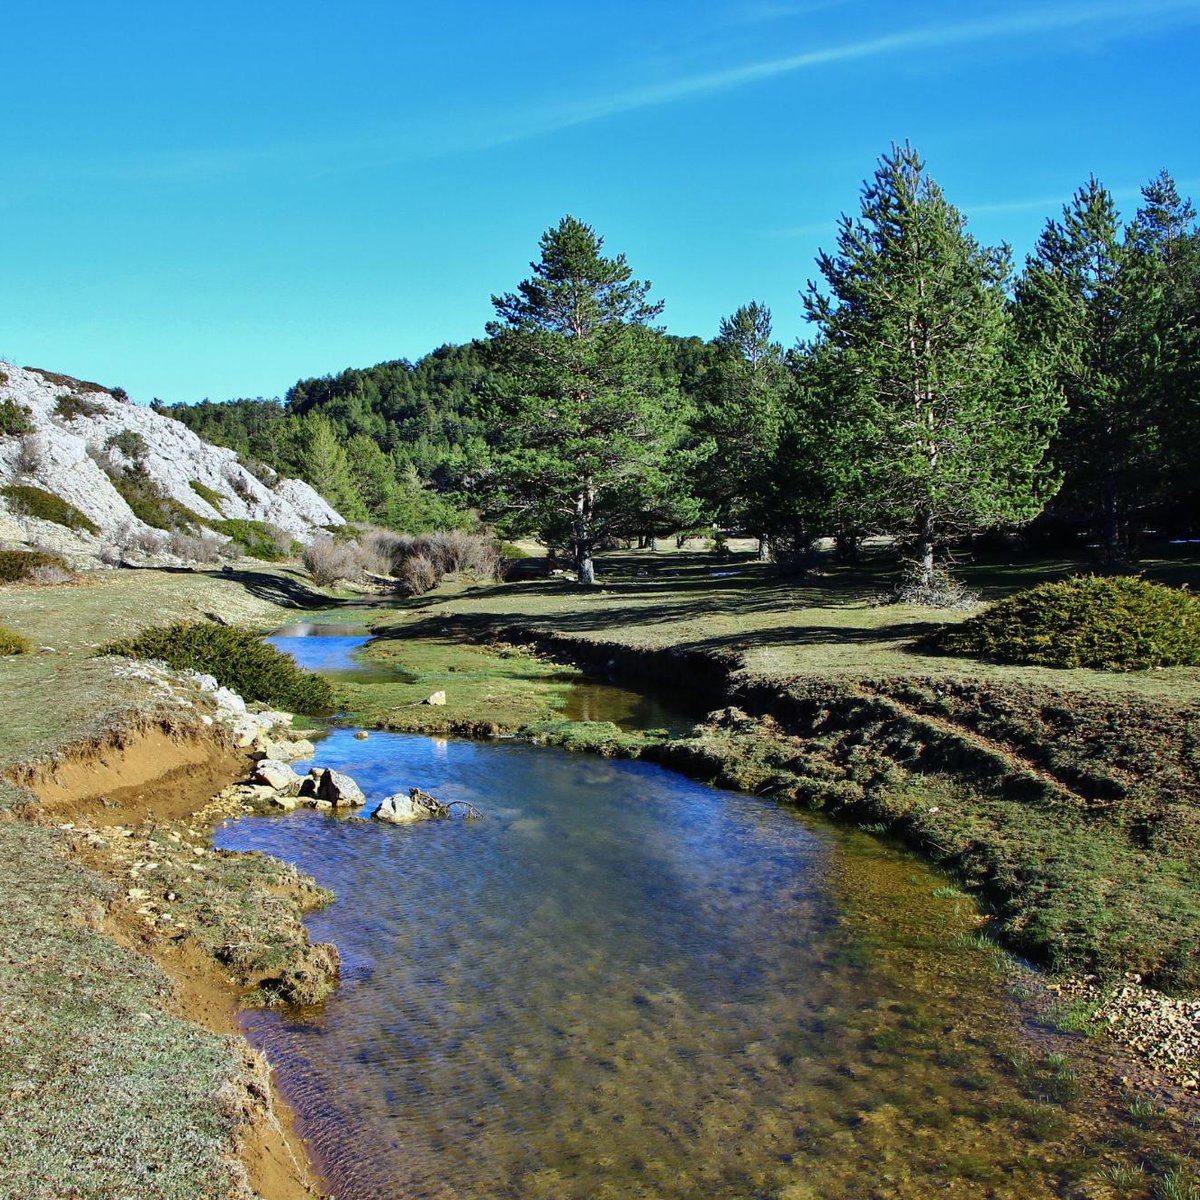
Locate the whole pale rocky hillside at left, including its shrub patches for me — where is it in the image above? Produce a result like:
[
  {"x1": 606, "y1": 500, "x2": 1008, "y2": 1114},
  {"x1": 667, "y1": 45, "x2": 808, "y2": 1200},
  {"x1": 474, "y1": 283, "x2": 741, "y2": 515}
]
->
[{"x1": 0, "y1": 366, "x2": 343, "y2": 565}]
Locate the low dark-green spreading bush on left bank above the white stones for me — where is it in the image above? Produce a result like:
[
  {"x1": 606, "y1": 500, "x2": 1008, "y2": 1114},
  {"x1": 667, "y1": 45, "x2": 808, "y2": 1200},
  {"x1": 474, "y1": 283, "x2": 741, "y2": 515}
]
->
[{"x1": 98, "y1": 622, "x2": 334, "y2": 714}]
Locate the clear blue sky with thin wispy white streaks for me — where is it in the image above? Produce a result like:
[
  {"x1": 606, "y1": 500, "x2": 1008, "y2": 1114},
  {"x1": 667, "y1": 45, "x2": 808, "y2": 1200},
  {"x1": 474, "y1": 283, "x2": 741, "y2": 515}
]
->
[{"x1": 0, "y1": 0, "x2": 1200, "y2": 402}]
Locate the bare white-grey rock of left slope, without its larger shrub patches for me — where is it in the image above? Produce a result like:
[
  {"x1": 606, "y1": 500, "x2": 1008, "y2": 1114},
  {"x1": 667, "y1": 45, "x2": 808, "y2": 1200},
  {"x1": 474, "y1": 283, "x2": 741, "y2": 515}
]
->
[{"x1": 0, "y1": 365, "x2": 343, "y2": 564}]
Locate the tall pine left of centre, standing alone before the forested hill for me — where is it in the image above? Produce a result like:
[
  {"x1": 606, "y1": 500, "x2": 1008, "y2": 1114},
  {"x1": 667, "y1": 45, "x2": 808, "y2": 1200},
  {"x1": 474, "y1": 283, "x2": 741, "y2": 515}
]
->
[{"x1": 487, "y1": 216, "x2": 674, "y2": 583}]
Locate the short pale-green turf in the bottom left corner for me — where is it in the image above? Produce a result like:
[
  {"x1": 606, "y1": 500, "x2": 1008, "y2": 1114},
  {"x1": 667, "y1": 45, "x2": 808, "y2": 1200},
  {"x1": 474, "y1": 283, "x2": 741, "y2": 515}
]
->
[{"x1": 0, "y1": 821, "x2": 241, "y2": 1200}]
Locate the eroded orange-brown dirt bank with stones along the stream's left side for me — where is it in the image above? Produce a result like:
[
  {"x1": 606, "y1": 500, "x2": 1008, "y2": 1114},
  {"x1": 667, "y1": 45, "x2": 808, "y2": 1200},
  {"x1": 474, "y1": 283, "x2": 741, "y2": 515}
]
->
[{"x1": 11, "y1": 721, "x2": 325, "y2": 1200}]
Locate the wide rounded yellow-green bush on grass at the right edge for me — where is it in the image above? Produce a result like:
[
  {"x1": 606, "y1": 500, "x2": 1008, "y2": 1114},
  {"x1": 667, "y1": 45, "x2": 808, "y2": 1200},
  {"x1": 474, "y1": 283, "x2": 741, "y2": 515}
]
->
[{"x1": 923, "y1": 576, "x2": 1200, "y2": 671}]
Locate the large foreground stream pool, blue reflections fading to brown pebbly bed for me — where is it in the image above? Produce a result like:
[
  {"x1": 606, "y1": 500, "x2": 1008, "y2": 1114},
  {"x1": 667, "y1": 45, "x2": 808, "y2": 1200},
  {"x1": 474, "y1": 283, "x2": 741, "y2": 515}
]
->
[{"x1": 218, "y1": 731, "x2": 1152, "y2": 1200}]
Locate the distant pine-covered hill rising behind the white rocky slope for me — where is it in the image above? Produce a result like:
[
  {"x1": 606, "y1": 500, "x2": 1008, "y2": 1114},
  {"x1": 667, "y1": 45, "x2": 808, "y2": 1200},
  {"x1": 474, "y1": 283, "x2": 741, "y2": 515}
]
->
[{"x1": 160, "y1": 334, "x2": 712, "y2": 532}]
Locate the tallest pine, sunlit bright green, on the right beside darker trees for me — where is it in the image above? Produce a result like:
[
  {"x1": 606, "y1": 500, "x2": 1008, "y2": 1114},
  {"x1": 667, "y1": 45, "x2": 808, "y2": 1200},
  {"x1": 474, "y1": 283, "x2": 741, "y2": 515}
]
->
[{"x1": 805, "y1": 144, "x2": 1055, "y2": 581}]
